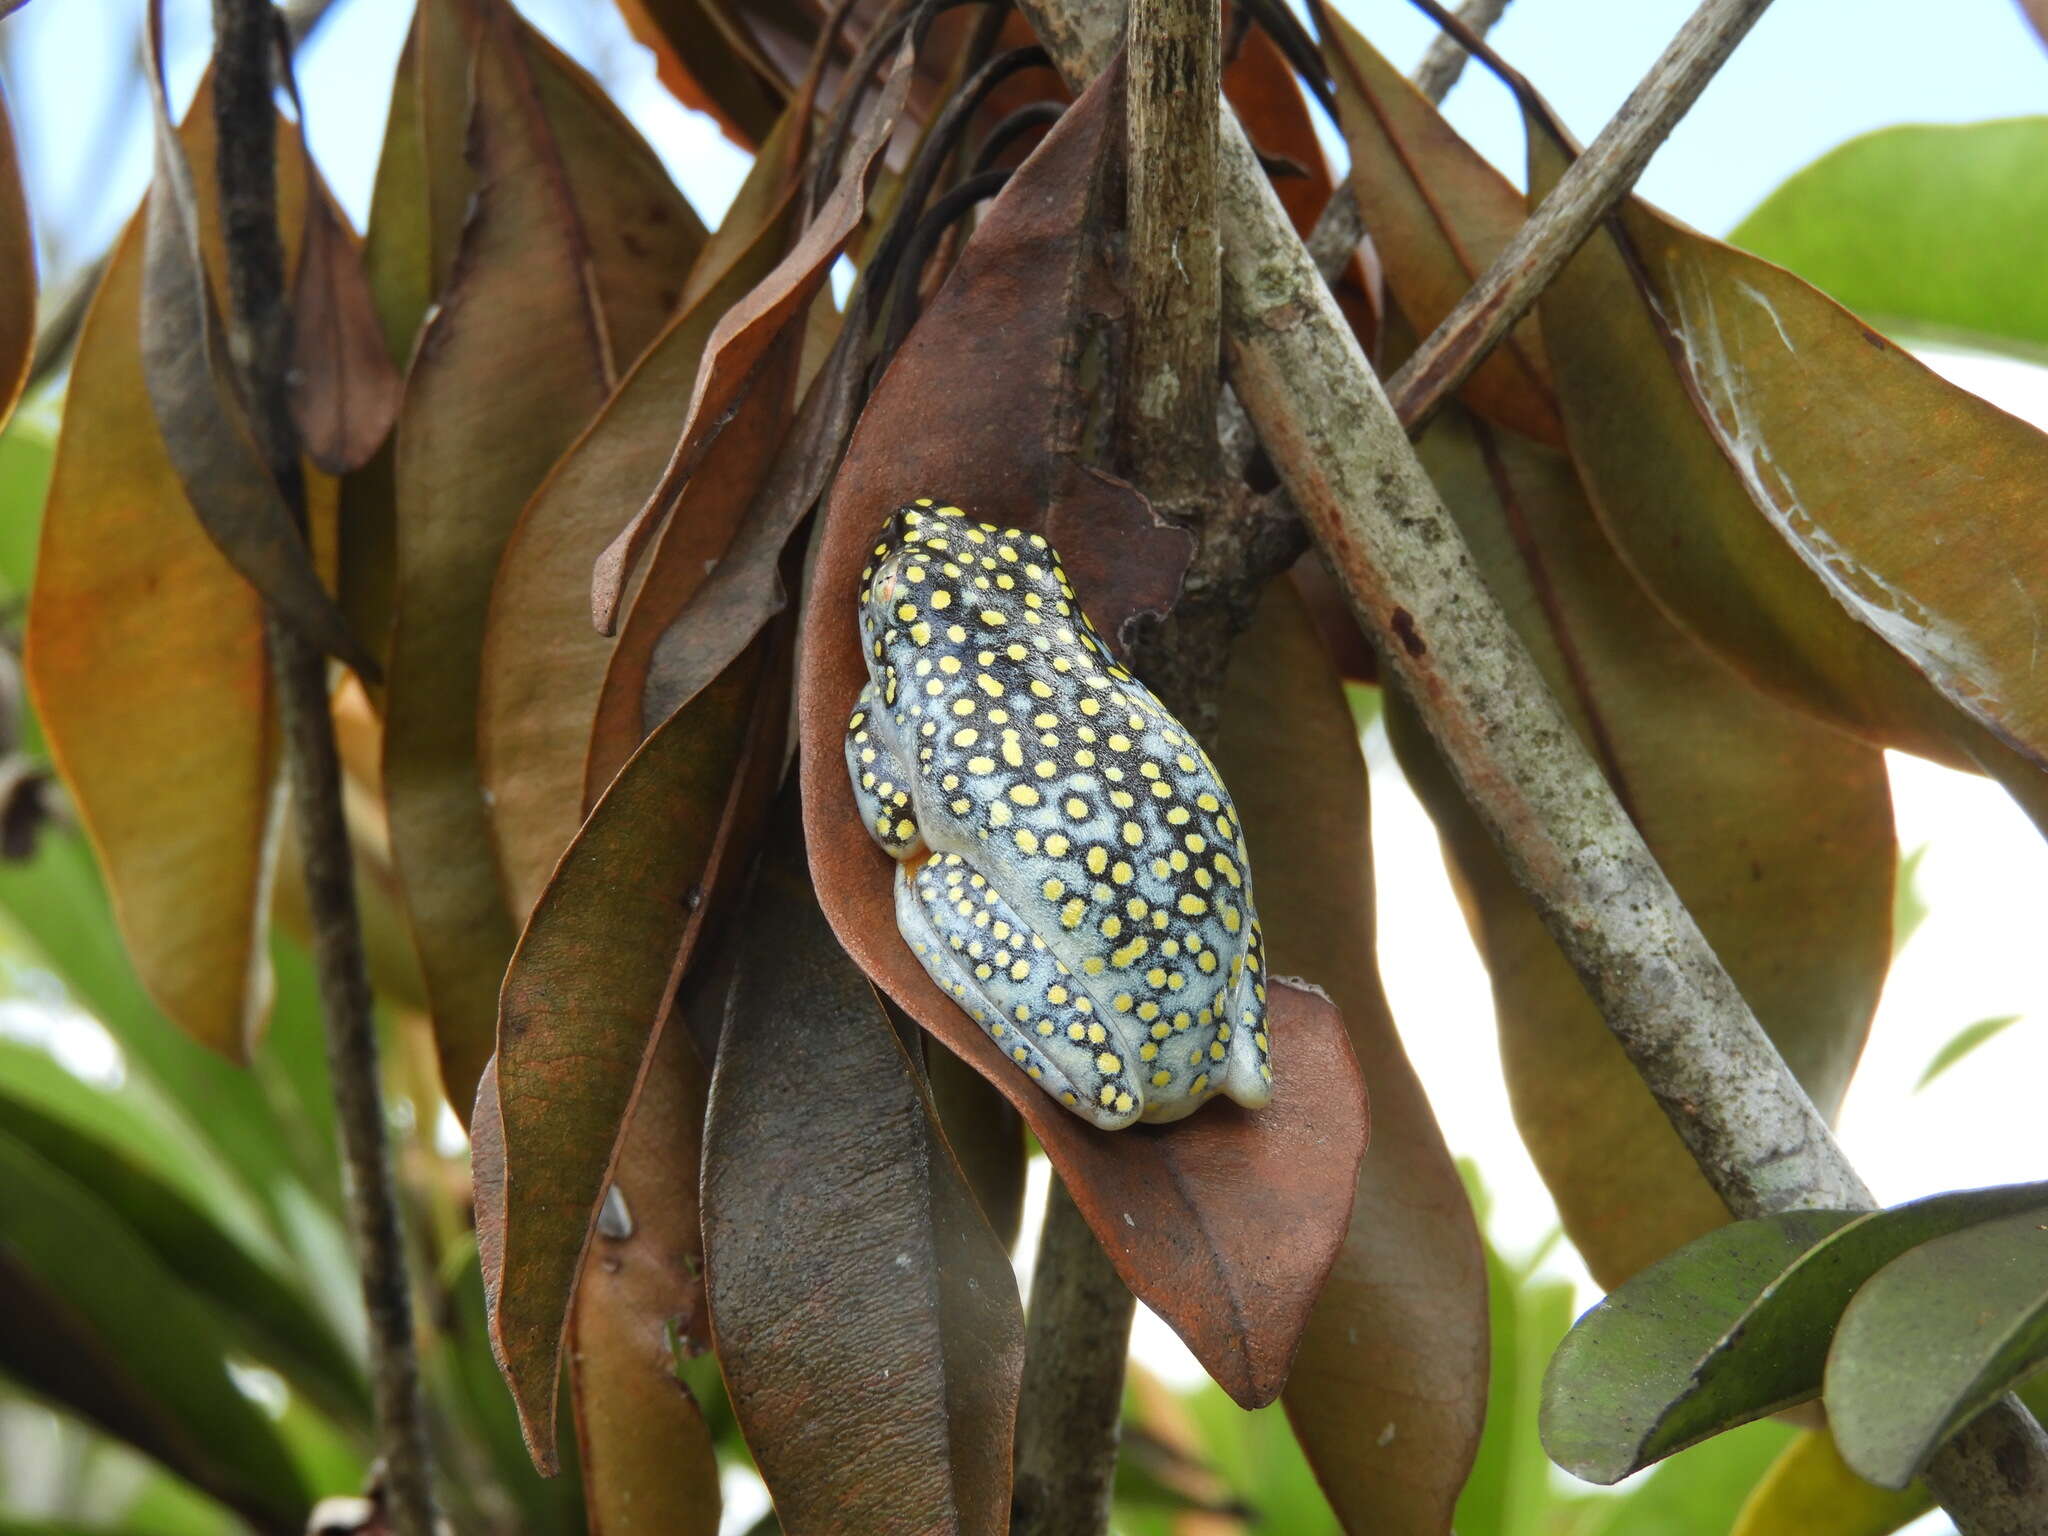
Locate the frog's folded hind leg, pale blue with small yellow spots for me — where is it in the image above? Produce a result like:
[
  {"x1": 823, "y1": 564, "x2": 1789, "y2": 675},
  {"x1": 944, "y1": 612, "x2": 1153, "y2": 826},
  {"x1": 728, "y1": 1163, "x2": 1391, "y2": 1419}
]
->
[{"x1": 895, "y1": 854, "x2": 1145, "y2": 1130}]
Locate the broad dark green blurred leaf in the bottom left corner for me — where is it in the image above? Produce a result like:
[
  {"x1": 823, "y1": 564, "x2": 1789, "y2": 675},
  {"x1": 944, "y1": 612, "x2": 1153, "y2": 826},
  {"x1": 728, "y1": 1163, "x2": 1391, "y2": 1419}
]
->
[{"x1": 0, "y1": 1133, "x2": 309, "y2": 1532}]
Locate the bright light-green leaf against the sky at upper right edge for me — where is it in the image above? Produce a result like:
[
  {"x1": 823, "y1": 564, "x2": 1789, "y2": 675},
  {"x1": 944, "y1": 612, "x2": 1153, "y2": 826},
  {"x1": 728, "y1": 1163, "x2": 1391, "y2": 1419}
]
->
[{"x1": 1729, "y1": 117, "x2": 2048, "y2": 360}]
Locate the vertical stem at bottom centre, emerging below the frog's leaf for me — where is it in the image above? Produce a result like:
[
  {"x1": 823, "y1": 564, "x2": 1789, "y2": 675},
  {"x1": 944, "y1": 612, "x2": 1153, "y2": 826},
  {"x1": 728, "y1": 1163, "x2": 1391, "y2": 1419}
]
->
[{"x1": 1010, "y1": 1178, "x2": 1137, "y2": 1536}]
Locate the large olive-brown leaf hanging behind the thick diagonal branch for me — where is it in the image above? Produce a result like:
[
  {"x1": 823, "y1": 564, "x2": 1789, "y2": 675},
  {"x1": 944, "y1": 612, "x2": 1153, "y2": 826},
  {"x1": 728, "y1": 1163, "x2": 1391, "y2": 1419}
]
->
[{"x1": 1389, "y1": 414, "x2": 1898, "y2": 1286}]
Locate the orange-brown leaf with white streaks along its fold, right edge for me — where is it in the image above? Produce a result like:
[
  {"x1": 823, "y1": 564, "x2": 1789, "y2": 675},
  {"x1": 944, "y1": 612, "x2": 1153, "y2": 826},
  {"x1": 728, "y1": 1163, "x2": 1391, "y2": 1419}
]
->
[{"x1": 1526, "y1": 102, "x2": 2048, "y2": 823}]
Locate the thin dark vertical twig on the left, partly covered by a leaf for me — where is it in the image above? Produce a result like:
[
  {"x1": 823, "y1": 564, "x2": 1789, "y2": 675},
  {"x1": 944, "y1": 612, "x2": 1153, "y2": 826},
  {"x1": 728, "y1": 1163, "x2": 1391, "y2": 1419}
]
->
[{"x1": 213, "y1": 0, "x2": 434, "y2": 1536}]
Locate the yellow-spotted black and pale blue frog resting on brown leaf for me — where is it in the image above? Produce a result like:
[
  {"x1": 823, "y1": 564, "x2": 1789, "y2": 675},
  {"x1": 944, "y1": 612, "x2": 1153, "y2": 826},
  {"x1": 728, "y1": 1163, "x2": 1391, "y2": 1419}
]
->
[{"x1": 846, "y1": 498, "x2": 1274, "y2": 1130}]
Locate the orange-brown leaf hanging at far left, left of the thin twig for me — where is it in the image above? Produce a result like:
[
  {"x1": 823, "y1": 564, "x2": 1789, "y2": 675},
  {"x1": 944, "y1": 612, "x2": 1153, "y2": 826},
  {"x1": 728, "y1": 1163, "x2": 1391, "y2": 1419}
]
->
[{"x1": 27, "y1": 90, "x2": 332, "y2": 1059}]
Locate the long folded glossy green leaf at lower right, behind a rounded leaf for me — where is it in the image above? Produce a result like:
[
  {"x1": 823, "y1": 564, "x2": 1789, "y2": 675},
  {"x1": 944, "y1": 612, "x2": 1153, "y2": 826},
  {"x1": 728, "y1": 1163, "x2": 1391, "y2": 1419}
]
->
[{"x1": 1542, "y1": 1184, "x2": 2048, "y2": 1483}]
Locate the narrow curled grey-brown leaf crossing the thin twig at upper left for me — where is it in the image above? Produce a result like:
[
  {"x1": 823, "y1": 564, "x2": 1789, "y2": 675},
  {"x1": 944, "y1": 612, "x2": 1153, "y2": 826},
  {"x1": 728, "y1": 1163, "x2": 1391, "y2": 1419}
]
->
[{"x1": 139, "y1": 2, "x2": 377, "y2": 678}]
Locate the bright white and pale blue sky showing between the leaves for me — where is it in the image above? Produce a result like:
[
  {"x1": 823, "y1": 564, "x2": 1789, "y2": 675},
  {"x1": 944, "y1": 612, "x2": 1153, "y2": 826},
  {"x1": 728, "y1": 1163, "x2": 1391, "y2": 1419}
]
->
[{"x1": 0, "y1": 0, "x2": 2048, "y2": 1524}]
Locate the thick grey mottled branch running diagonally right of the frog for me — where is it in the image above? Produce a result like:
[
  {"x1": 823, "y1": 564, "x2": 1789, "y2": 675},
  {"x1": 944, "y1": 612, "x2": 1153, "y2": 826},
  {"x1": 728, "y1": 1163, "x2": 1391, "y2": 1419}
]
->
[{"x1": 1024, "y1": 0, "x2": 2048, "y2": 1536}]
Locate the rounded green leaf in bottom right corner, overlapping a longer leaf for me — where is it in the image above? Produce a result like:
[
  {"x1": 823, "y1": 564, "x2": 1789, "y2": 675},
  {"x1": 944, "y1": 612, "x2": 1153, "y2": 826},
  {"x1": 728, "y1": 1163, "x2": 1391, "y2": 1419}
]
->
[{"x1": 1827, "y1": 1212, "x2": 2048, "y2": 1489}]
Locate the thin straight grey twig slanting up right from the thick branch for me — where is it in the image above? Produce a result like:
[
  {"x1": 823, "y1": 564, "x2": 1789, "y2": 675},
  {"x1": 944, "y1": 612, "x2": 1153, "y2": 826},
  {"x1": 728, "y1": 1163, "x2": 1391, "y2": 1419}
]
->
[{"x1": 1386, "y1": 0, "x2": 1769, "y2": 432}]
